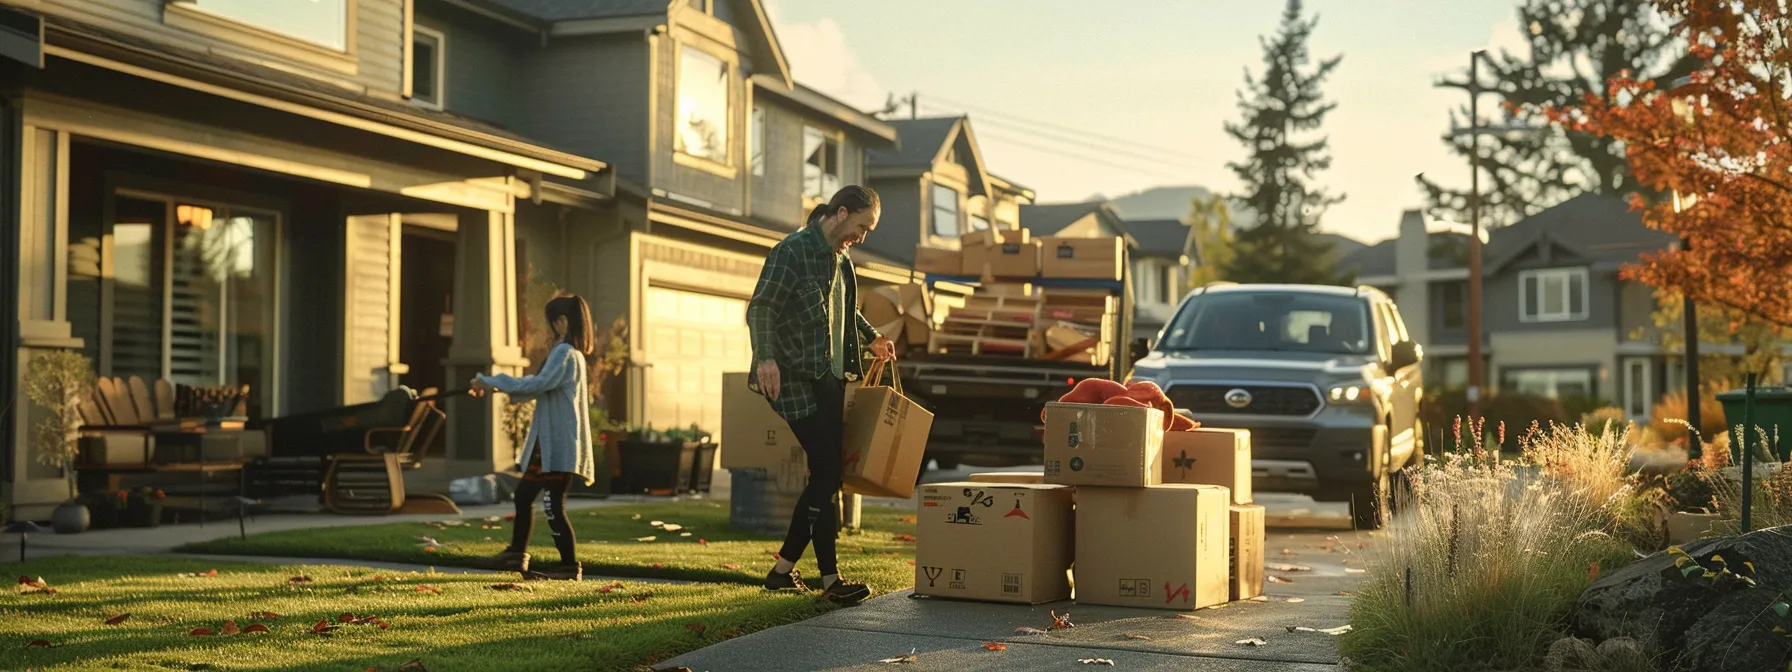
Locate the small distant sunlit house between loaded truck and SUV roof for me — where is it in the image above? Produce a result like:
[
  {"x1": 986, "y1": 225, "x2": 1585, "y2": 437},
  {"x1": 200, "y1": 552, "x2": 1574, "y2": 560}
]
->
[{"x1": 1125, "y1": 219, "x2": 1201, "y2": 337}]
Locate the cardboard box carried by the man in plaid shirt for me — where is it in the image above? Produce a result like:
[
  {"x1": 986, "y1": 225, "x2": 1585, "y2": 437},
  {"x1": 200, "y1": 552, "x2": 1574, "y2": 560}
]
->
[{"x1": 838, "y1": 385, "x2": 934, "y2": 498}]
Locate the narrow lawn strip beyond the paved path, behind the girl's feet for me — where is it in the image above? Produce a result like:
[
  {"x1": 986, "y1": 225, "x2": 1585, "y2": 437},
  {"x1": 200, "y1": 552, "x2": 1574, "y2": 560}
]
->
[{"x1": 179, "y1": 502, "x2": 914, "y2": 593}]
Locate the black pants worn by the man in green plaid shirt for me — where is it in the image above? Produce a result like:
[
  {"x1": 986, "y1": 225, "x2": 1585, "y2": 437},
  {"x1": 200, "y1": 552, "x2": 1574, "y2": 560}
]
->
[{"x1": 778, "y1": 375, "x2": 846, "y2": 575}]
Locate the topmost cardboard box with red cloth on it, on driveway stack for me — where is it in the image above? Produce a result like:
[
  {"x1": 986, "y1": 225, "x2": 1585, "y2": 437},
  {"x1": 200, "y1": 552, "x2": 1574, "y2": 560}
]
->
[{"x1": 1045, "y1": 401, "x2": 1163, "y2": 487}]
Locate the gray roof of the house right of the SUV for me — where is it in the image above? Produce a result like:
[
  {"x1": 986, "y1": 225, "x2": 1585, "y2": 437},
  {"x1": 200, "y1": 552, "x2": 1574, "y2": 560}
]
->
[{"x1": 1486, "y1": 194, "x2": 1677, "y2": 271}]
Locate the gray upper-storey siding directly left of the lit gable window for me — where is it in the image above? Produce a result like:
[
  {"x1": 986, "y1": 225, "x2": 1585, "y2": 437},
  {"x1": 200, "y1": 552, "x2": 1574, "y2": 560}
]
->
[{"x1": 519, "y1": 34, "x2": 652, "y2": 183}]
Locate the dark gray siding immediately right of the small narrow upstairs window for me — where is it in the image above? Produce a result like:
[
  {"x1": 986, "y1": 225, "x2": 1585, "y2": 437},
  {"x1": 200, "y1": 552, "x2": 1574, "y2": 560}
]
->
[{"x1": 416, "y1": 0, "x2": 526, "y2": 129}]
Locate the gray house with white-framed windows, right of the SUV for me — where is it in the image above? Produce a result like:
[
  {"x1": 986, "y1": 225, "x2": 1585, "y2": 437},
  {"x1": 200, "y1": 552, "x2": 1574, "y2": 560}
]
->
[{"x1": 1342, "y1": 195, "x2": 1763, "y2": 419}]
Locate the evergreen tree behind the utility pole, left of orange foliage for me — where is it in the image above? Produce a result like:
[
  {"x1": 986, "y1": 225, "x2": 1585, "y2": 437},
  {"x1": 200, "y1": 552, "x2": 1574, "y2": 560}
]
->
[{"x1": 1419, "y1": 0, "x2": 1695, "y2": 228}]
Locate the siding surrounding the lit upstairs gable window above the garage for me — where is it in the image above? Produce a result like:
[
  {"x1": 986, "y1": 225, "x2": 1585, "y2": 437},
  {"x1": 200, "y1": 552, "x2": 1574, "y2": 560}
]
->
[{"x1": 655, "y1": 36, "x2": 749, "y2": 211}]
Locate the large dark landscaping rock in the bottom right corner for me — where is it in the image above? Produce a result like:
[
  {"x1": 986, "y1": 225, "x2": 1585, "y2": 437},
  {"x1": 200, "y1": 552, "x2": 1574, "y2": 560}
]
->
[{"x1": 1573, "y1": 527, "x2": 1792, "y2": 672}]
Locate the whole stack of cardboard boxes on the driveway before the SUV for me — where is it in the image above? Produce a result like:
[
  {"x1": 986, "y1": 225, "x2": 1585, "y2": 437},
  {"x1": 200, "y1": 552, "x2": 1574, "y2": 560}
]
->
[{"x1": 916, "y1": 403, "x2": 1263, "y2": 609}]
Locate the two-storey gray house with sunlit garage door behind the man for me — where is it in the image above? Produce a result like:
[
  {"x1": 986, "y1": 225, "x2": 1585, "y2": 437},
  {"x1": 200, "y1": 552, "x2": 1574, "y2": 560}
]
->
[{"x1": 437, "y1": 0, "x2": 909, "y2": 442}]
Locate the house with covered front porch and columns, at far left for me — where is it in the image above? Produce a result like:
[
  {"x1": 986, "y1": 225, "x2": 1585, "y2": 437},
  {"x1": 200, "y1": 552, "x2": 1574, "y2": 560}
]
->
[{"x1": 0, "y1": 0, "x2": 613, "y2": 518}]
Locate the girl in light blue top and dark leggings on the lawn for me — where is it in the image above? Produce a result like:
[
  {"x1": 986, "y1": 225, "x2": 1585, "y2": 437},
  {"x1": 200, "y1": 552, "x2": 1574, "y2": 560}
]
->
[{"x1": 471, "y1": 294, "x2": 597, "y2": 581}]
